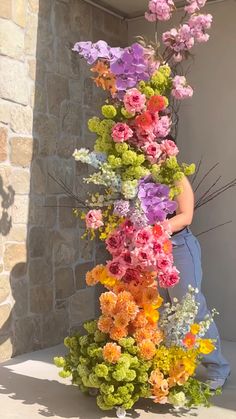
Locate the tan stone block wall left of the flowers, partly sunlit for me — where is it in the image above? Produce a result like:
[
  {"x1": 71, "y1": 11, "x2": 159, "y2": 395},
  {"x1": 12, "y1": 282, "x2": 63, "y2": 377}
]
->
[{"x1": 0, "y1": 0, "x2": 127, "y2": 360}]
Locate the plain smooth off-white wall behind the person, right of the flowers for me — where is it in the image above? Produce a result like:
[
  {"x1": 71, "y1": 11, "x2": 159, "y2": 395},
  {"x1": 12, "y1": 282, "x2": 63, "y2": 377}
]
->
[{"x1": 129, "y1": 0, "x2": 236, "y2": 340}]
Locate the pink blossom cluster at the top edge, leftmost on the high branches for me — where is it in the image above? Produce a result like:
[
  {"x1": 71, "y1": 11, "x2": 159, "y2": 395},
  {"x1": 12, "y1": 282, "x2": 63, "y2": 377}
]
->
[{"x1": 145, "y1": 0, "x2": 174, "y2": 22}]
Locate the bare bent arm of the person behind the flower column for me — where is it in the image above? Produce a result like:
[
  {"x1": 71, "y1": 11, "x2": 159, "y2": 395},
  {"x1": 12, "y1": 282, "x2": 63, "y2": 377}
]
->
[{"x1": 168, "y1": 176, "x2": 194, "y2": 233}]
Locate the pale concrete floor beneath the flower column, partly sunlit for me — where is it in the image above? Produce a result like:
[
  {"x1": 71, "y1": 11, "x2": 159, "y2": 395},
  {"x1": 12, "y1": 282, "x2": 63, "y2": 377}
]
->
[{"x1": 0, "y1": 342, "x2": 236, "y2": 419}]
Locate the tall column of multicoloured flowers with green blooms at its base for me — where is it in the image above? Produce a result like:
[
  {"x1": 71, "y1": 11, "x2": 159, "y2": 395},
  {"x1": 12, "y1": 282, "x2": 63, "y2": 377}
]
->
[{"x1": 55, "y1": 0, "x2": 221, "y2": 414}]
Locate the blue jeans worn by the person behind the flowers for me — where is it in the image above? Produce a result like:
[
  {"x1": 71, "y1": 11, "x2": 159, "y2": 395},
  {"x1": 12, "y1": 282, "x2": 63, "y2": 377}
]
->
[{"x1": 159, "y1": 227, "x2": 230, "y2": 379}]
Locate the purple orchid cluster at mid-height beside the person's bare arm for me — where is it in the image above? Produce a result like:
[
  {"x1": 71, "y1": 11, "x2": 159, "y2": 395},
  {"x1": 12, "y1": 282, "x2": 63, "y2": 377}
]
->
[{"x1": 138, "y1": 176, "x2": 177, "y2": 224}]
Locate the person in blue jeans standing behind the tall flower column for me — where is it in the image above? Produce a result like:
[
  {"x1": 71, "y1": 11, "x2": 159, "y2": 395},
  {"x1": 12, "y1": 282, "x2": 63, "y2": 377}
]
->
[{"x1": 160, "y1": 171, "x2": 230, "y2": 390}]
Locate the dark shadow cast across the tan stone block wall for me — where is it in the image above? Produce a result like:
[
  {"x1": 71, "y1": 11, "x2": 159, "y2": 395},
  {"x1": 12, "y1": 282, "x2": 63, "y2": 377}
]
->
[{"x1": 0, "y1": 0, "x2": 127, "y2": 359}]
